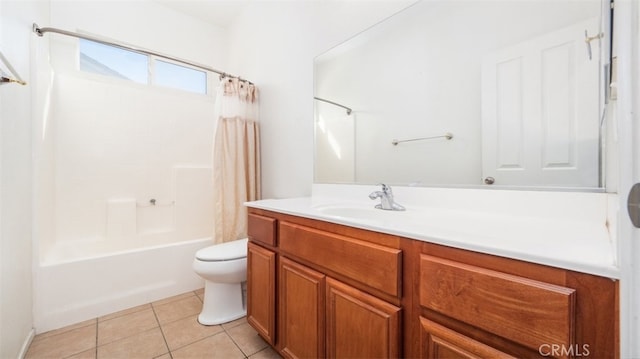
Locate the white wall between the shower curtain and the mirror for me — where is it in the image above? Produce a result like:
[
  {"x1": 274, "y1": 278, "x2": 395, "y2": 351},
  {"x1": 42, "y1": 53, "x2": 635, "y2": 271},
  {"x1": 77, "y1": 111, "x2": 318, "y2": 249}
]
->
[{"x1": 228, "y1": 1, "x2": 413, "y2": 198}]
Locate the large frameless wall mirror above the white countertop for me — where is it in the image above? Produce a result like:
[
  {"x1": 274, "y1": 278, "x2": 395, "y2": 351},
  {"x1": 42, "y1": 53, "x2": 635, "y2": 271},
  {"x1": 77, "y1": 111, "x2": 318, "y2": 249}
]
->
[{"x1": 314, "y1": 0, "x2": 608, "y2": 191}]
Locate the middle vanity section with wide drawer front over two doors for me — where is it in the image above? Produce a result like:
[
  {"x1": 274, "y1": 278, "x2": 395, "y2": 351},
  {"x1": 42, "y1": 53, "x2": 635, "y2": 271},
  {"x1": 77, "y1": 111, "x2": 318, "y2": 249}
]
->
[{"x1": 278, "y1": 221, "x2": 402, "y2": 358}]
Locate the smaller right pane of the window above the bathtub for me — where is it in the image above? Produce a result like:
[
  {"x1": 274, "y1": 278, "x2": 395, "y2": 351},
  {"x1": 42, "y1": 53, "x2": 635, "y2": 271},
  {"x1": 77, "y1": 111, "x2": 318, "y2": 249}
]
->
[{"x1": 155, "y1": 60, "x2": 207, "y2": 94}]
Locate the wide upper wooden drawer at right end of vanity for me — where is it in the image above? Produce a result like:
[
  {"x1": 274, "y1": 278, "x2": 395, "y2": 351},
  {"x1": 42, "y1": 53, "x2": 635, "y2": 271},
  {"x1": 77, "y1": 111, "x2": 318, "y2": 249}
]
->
[{"x1": 420, "y1": 254, "x2": 576, "y2": 350}]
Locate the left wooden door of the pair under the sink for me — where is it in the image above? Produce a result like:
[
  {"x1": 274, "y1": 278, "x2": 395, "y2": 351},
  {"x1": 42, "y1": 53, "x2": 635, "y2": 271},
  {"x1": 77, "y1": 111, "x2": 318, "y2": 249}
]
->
[{"x1": 278, "y1": 257, "x2": 325, "y2": 358}]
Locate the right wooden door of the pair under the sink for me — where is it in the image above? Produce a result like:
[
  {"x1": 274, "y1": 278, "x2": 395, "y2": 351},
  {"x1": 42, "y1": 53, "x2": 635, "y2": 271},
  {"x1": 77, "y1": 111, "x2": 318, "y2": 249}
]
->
[{"x1": 327, "y1": 278, "x2": 401, "y2": 358}]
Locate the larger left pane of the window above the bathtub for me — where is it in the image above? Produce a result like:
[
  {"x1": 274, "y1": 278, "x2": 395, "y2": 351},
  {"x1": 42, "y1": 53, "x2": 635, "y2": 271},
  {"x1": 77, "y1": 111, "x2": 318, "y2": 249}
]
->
[{"x1": 80, "y1": 39, "x2": 149, "y2": 84}]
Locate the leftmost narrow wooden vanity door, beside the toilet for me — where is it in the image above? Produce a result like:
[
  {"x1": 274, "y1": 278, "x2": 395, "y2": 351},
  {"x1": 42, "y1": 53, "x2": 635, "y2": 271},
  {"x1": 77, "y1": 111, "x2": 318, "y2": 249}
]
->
[{"x1": 247, "y1": 242, "x2": 276, "y2": 345}]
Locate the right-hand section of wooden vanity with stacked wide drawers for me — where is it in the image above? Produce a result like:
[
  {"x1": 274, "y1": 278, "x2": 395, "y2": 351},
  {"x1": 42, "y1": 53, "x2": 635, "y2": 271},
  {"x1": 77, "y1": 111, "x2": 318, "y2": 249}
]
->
[{"x1": 418, "y1": 243, "x2": 618, "y2": 358}]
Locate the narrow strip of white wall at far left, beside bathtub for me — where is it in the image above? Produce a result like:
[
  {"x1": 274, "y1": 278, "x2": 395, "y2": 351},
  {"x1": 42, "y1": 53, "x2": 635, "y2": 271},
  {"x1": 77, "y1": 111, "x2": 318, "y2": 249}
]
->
[{"x1": 0, "y1": 1, "x2": 48, "y2": 358}]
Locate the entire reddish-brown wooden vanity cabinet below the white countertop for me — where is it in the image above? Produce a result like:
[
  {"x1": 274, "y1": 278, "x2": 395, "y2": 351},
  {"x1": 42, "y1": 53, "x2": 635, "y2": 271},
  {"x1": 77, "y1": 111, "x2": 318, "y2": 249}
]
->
[{"x1": 248, "y1": 208, "x2": 619, "y2": 358}]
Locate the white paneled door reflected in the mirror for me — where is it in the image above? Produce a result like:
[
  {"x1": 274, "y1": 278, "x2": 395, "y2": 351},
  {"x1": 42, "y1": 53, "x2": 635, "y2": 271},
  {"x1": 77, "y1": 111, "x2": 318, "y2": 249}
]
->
[{"x1": 482, "y1": 19, "x2": 600, "y2": 187}]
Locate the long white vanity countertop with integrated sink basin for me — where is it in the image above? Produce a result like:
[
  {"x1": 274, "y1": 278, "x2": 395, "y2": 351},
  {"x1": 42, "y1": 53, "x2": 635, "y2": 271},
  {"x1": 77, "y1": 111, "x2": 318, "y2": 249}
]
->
[{"x1": 246, "y1": 185, "x2": 619, "y2": 278}]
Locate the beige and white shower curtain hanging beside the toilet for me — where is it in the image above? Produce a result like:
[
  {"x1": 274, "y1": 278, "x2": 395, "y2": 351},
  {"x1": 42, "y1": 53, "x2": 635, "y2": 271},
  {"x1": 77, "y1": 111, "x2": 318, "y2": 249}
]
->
[{"x1": 213, "y1": 78, "x2": 260, "y2": 243}]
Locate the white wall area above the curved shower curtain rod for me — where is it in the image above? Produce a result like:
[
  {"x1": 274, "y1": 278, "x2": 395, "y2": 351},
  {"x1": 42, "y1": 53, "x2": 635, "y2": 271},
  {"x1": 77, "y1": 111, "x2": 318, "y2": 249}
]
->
[{"x1": 50, "y1": 0, "x2": 227, "y2": 68}]
